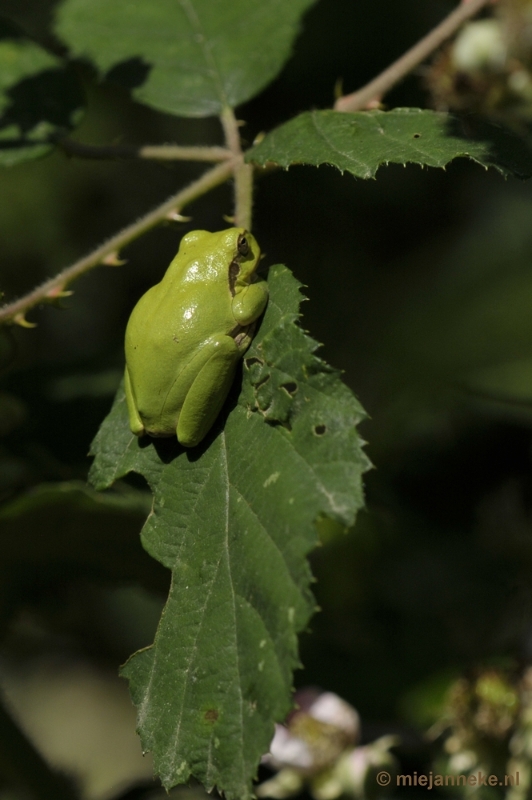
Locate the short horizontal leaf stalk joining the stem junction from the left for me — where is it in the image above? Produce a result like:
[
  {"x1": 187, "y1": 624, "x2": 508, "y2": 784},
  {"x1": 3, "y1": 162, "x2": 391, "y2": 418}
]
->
[{"x1": 56, "y1": 138, "x2": 232, "y2": 161}]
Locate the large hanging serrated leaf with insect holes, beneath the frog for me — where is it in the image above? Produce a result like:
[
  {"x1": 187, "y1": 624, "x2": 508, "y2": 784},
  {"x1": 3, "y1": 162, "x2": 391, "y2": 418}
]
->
[{"x1": 88, "y1": 265, "x2": 368, "y2": 800}]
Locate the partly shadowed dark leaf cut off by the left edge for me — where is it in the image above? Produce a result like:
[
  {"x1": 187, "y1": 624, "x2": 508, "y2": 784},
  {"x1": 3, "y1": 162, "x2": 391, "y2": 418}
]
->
[{"x1": 0, "y1": 20, "x2": 83, "y2": 167}]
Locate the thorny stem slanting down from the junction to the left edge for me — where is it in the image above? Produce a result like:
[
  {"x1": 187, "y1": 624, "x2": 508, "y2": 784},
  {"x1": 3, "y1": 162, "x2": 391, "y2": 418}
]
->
[{"x1": 0, "y1": 160, "x2": 235, "y2": 327}]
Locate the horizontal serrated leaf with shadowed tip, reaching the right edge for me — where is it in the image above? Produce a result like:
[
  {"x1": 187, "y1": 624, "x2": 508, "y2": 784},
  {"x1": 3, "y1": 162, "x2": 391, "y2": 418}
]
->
[{"x1": 246, "y1": 108, "x2": 532, "y2": 178}]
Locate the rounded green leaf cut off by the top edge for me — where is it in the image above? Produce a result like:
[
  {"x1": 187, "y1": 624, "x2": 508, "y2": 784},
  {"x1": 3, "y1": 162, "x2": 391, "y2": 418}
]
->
[{"x1": 56, "y1": 0, "x2": 315, "y2": 117}]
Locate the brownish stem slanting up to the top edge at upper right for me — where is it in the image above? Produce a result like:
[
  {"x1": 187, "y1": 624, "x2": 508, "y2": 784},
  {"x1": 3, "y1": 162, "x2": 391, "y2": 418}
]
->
[{"x1": 334, "y1": 0, "x2": 491, "y2": 111}]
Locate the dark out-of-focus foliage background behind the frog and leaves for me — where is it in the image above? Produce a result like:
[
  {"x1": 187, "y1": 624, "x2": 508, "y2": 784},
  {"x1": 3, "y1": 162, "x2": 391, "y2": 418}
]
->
[{"x1": 0, "y1": 0, "x2": 532, "y2": 800}]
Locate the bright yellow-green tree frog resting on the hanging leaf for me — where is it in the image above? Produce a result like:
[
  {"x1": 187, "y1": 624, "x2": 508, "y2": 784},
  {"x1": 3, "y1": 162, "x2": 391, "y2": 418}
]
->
[{"x1": 125, "y1": 228, "x2": 268, "y2": 447}]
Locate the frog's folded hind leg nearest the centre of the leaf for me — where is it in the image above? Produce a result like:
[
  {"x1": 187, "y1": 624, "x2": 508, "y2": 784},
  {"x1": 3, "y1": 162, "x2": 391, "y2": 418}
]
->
[{"x1": 176, "y1": 336, "x2": 240, "y2": 447}]
